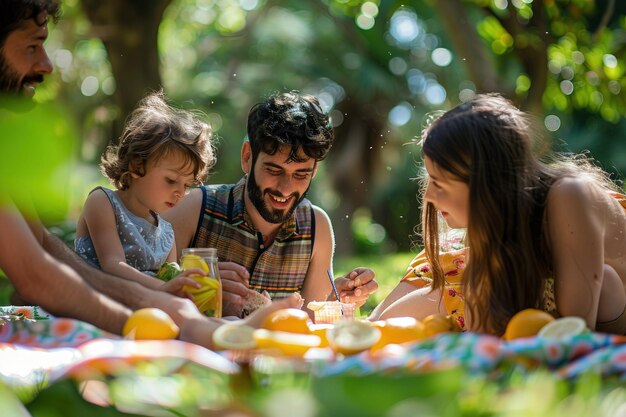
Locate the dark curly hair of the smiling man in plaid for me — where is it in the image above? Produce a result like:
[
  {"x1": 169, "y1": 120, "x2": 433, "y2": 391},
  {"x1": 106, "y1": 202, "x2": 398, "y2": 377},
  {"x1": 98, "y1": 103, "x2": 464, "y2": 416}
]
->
[{"x1": 248, "y1": 91, "x2": 335, "y2": 162}]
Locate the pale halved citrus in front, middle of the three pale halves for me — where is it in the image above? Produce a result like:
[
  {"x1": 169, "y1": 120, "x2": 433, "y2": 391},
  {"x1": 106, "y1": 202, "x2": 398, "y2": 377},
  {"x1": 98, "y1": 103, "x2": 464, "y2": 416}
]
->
[{"x1": 326, "y1": 320, "x2": 380, "y2": 355}]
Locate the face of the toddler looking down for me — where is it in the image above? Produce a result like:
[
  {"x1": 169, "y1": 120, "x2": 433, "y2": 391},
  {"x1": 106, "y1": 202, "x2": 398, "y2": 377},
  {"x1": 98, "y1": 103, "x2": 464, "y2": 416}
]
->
[{"x1": 129, "y1": 152, "x2": 195, "y2": 214}]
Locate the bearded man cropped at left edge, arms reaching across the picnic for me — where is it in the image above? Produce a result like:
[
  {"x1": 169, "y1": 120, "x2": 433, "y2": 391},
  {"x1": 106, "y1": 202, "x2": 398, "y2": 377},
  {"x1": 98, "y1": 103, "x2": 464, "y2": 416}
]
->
[{"x1": 0, "y1": 0, "x2": 299, "y2": 347}]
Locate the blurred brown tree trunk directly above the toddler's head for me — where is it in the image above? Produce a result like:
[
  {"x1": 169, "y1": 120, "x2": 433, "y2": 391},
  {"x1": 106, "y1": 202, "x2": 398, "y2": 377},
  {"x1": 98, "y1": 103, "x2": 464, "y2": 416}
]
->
[{"x1": 81, "y1": 0, "x2": 171, "y2": 140}]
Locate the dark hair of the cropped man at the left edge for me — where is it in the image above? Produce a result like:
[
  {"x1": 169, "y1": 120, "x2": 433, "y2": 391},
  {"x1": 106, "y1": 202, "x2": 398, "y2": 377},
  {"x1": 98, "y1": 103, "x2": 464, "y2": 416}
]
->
[{"x1": 0, "y1": 0, "x2": 61, "y2": 49}]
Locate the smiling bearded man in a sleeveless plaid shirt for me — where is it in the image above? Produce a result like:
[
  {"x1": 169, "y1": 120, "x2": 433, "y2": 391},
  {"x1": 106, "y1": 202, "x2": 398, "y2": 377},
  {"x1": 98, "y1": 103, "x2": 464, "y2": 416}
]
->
[{"x1": 164, "y1": 91, "x2": 378, "y2": 316}]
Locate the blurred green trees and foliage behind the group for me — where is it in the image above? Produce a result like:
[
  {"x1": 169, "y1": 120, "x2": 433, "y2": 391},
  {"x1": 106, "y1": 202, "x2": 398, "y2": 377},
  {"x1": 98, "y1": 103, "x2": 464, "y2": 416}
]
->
[{"x1": 37, "y1": 0, "x2": 626, "y2": 262}]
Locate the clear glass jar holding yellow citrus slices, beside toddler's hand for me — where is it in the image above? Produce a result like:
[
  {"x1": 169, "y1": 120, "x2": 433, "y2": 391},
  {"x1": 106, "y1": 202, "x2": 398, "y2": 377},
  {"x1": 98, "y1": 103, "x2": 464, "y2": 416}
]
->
[{"x1": 180, "y1": 248, "x2": 222, "y2": 317}]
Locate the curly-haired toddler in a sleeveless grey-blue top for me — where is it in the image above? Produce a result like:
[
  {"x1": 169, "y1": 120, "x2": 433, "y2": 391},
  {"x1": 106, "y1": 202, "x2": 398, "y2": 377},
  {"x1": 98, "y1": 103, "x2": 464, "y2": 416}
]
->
[{"x1": 75, "y1": 93, "x2": 215, "y2": 296}]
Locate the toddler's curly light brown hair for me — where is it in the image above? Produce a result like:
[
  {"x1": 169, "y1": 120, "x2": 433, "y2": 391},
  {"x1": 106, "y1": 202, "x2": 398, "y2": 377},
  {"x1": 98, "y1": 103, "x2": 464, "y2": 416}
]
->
[{"x1": 100, "y1": 91, "x2": 215, "y2": 190}]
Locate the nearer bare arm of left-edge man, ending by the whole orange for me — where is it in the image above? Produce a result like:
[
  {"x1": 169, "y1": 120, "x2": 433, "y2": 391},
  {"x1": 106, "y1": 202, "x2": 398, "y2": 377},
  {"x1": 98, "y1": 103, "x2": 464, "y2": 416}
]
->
[{"x1": 0, "y1": 207, "x2": 130, "y2": 334}]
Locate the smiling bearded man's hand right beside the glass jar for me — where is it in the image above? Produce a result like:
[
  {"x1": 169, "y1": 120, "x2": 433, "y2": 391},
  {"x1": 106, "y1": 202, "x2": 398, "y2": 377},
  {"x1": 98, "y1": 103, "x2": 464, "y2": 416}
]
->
[{"x1": 218, "y1": 262, "x2": 253, "y2": 317}]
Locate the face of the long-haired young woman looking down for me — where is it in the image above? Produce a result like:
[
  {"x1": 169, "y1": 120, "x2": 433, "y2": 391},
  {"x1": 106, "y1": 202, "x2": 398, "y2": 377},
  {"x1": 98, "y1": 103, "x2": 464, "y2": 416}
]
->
[{"x1": 424, "y1": 156, "x2": 469, "y2": 229}]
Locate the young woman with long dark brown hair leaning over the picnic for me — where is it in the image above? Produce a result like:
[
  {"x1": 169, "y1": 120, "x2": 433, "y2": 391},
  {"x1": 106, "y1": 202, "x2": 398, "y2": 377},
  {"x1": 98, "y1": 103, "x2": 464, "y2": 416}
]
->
[{"x1": 372, "y1": 95, "x2": 626, "y2": 335}]
